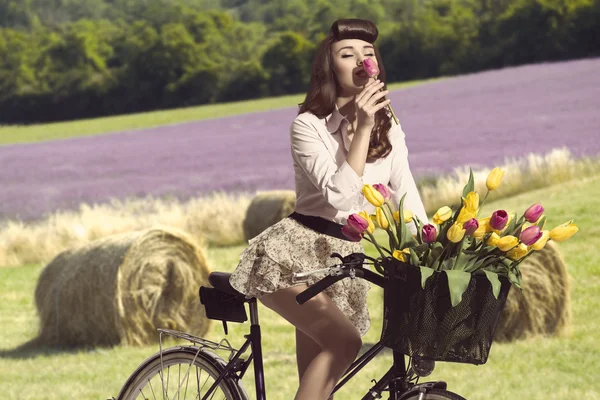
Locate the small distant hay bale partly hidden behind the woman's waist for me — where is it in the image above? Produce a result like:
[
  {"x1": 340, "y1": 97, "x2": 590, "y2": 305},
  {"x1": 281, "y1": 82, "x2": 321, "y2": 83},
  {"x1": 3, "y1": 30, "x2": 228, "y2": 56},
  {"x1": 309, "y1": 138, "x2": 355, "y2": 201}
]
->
[{"x1": 243, "y1": 190, "x2": 296, "y2": 242}]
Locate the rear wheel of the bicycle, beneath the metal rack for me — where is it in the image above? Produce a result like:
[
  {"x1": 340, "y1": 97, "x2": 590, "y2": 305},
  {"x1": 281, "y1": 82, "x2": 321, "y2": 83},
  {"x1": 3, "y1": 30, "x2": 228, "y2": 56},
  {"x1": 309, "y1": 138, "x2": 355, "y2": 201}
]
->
[{"x1": 117, "y1": 347, "x2": 248, "y2": 400}]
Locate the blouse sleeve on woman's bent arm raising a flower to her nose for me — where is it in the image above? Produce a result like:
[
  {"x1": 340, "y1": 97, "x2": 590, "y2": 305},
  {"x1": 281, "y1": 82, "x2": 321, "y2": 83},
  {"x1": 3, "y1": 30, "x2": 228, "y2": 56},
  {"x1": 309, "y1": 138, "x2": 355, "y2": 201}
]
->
[{"x1": 290, "y1": 118, "x2": 363, "y2": 211}]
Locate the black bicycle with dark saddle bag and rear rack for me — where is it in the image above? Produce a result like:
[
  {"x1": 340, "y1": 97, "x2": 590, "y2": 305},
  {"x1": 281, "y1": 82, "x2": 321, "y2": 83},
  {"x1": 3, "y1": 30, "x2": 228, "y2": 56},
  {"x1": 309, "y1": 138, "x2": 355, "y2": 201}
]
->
[{"x1": 113, "y1": 253, "x2": 503, "y2": 400}]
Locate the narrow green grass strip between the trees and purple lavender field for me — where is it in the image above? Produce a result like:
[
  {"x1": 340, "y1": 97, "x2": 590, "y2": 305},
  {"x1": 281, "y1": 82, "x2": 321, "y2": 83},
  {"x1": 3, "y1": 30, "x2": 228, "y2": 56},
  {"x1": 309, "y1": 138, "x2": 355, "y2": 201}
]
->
[{"x1": 0, "y1": 78, "x2": 443, "y2": 146}]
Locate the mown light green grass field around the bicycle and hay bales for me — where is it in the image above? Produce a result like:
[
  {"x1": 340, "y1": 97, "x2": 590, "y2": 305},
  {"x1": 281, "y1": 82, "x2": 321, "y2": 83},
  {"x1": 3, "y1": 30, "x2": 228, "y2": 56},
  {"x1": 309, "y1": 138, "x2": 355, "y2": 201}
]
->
[{"x1": 0, "y1": 177, "x2": 600, "y2": 400}]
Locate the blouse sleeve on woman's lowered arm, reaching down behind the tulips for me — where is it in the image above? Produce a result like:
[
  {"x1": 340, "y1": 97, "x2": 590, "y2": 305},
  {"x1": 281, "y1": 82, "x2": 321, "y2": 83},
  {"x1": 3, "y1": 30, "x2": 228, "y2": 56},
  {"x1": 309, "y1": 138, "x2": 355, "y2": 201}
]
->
[{"x1": 389, "y1": 123, "x2": 429, "y2": 234}]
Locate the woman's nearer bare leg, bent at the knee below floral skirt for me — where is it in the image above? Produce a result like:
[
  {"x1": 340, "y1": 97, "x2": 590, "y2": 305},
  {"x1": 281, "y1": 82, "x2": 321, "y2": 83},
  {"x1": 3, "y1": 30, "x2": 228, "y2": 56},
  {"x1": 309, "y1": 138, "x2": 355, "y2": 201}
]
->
[{"x1": 260, "y1": 285, "x2": 362, "y2": 400}]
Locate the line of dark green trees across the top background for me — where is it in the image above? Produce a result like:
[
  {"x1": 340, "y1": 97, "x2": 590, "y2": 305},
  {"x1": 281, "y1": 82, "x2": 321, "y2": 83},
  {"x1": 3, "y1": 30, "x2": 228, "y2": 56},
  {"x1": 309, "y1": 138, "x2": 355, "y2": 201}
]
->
[{"x1": 0, "y1": 0, "x2": 600, "y2": 123}]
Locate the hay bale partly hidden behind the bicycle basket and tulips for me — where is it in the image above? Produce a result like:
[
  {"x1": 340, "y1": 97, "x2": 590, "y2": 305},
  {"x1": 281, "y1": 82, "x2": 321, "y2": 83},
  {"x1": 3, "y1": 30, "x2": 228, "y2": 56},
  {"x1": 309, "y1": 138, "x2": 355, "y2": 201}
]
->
[{"x1": 494, "y1": 241, "x2": 571, "y2": 342}]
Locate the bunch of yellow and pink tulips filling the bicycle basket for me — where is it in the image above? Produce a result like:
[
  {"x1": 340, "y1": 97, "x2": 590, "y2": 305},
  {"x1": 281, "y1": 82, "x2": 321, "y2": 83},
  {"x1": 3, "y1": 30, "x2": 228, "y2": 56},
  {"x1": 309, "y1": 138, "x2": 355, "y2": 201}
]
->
[{"x1": 342, "y1": 168, "x2": 578, "y2": 306}]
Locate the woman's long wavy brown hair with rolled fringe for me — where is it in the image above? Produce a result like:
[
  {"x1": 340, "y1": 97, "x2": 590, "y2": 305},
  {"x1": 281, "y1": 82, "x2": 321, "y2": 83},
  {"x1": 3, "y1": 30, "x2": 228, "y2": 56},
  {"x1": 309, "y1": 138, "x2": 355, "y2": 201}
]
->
[{"x1": 298, "y1": 19, "x2": 392, "y2": 163}]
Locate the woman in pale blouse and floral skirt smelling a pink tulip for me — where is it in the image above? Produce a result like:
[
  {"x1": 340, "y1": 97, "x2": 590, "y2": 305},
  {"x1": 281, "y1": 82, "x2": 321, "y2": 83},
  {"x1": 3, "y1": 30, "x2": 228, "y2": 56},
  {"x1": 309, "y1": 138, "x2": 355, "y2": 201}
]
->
[{"x1": 230, "y1": 19, "x2": 427, "y2": 400}]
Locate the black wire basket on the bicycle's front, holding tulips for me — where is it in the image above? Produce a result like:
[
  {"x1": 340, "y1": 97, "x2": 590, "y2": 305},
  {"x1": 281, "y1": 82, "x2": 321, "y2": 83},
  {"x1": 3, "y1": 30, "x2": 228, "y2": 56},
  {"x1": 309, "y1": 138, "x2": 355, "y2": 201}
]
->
[{"x1": 381, "y1": 258, "x2": 511, "y2": 365}]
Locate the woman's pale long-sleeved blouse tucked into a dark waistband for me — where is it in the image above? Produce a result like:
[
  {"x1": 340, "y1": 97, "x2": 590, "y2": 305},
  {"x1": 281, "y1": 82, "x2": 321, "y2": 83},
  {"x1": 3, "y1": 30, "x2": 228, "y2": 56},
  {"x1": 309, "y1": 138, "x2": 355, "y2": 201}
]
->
[{"x1": 290, "y1": 106, "x2": 428, "y2": 233}]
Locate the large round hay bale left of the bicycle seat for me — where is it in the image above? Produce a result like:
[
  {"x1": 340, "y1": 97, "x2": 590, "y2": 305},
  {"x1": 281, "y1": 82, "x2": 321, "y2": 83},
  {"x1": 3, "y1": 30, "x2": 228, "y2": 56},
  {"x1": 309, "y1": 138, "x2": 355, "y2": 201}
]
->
[{"x1": 31, "y1": 228, "x2": 210, "y2": 346}]
